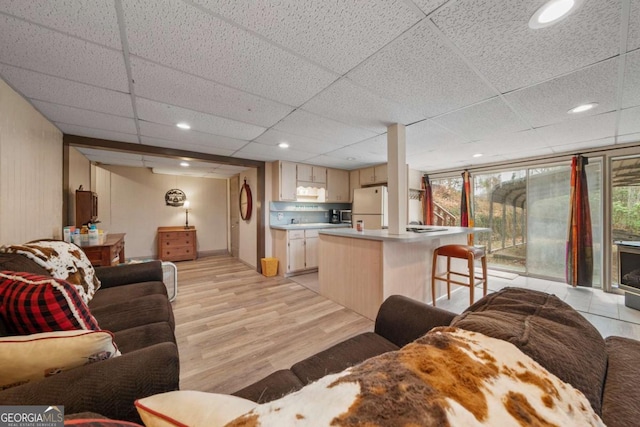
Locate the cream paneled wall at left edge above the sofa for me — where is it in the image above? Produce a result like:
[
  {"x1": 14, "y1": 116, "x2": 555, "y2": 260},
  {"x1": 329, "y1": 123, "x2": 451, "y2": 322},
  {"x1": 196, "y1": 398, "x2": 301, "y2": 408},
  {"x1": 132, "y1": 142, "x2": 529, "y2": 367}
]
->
[{"x1": 0, "y1": 79, "x2": 63, "y2": 244}]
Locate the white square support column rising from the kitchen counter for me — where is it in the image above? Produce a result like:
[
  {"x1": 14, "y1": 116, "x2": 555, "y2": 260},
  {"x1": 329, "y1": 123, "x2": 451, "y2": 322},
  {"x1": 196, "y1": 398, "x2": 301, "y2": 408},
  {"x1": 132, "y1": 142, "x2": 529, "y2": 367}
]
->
[{"x1": 387, "y1": 123, "x2": 409, "y2": 234}]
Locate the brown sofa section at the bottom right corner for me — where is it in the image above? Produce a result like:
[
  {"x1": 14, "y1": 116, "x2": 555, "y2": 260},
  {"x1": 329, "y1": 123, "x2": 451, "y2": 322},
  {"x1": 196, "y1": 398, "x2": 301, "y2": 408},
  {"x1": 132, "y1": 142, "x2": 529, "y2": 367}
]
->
[{"x1": 602, "y1": 337, "x2": 640, "y2": 427}]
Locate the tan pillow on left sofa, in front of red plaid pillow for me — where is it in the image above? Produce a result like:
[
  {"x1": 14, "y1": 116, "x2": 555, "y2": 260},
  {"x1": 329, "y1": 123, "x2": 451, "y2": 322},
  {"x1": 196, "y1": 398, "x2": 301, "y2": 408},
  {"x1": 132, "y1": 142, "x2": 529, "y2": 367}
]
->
[{"x1": 0, "y1": 330, "x2": 120, "y2": 389}]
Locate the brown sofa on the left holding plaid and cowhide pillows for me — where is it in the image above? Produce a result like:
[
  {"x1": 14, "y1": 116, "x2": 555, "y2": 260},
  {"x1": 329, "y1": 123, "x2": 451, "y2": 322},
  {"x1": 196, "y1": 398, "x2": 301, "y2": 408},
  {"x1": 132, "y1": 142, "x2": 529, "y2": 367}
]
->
[{"x1": 0, "y1": 254, "x2": 180, "y2": 422}]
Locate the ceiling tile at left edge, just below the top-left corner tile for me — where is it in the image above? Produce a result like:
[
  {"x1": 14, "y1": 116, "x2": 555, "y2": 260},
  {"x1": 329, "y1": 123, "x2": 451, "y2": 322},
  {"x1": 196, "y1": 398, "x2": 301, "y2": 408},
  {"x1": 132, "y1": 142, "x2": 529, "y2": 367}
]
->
[{"x1": 0, "y1": 15, "x2": 129, "y2": 92}]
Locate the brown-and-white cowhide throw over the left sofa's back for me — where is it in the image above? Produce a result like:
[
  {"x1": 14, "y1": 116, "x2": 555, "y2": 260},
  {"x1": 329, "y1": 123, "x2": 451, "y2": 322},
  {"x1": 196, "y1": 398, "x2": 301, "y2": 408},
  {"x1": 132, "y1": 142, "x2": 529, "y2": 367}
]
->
[{"x1": 0, "y1": 239, "x2": 100, "y2": 303}]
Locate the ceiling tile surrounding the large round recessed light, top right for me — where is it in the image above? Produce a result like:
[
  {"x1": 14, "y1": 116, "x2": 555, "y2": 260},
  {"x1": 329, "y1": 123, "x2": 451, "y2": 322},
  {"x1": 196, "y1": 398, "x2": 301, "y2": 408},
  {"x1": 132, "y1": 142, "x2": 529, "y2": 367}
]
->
[{"x1": 431, "y1": 0, "x2": 621, "y2": 93}]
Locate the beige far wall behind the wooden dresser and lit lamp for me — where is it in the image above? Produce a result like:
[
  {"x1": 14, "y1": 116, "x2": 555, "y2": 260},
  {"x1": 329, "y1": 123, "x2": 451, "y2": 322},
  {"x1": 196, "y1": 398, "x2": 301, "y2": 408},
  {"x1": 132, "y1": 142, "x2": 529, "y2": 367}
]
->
[{"x1": 95, "y1": 166, "x2": 228, "y2": 258}]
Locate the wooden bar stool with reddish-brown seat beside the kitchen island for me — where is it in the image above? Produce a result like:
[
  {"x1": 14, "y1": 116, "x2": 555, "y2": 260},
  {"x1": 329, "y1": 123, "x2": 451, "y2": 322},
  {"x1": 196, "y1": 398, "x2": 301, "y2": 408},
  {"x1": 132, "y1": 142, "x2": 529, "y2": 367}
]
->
[{"x1": 431, "y1": 245, "x2": 487, "y2": 307}]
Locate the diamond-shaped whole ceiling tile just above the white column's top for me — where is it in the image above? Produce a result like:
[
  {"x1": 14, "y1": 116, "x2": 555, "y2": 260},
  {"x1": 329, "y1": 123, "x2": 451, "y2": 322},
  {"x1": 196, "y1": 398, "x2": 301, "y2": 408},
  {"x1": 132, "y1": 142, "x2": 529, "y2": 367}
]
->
[{"x1": 347, "y1": 20, "x2": 495, "y2": 117}]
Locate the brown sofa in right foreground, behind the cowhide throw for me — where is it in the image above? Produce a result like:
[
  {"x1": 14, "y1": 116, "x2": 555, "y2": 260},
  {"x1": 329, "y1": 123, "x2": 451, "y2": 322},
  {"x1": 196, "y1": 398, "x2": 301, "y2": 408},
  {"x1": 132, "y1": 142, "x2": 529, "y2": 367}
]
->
[{"x1": 234, "y1": 288, "x2": 640, "y2": 427}]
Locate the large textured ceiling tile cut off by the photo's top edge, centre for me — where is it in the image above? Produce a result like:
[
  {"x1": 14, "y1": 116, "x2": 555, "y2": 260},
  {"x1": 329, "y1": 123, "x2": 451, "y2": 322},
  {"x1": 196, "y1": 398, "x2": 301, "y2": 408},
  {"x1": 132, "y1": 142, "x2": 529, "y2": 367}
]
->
[{"x1": 195, "y1": 0, "x2": 423, "y2": 74}]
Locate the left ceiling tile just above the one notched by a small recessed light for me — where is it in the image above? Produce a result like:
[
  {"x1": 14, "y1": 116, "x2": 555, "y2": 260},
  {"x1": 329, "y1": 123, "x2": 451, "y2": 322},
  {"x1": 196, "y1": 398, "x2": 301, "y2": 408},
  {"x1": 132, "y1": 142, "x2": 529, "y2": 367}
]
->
[{"x1": 131, "y1": 57, "x2": 293, "y2": 127}]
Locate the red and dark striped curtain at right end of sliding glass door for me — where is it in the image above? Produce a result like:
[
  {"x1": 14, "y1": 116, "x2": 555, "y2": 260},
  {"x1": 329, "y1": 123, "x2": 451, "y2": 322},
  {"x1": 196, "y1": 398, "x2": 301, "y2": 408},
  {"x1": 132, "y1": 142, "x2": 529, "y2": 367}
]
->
[{"x1": 566, "y1": 156, "x2": 593, "y2": 287}]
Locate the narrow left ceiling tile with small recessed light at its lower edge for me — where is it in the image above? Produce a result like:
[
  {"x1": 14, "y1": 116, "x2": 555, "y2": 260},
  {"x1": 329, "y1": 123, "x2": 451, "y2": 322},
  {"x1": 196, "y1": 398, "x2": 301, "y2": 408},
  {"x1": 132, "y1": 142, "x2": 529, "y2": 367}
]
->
[{"x1": 136, "y1": 98, "x2": 266, "y2": 140}]
